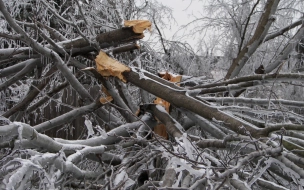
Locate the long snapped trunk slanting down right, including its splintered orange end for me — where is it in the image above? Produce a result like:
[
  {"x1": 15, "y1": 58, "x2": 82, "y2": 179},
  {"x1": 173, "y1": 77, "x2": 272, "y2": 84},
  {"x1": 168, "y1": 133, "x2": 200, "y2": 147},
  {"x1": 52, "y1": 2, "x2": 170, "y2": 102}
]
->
[{"x1": 96, "y1": 52, "x2": 267, "y2": 137}]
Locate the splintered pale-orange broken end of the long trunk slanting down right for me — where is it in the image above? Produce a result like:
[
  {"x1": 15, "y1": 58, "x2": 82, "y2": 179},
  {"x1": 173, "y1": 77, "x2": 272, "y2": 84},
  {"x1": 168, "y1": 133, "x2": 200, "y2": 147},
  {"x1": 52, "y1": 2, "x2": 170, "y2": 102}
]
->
[{"x1": 95, "y1": 51, "x2": 130, "y2": 82}]
